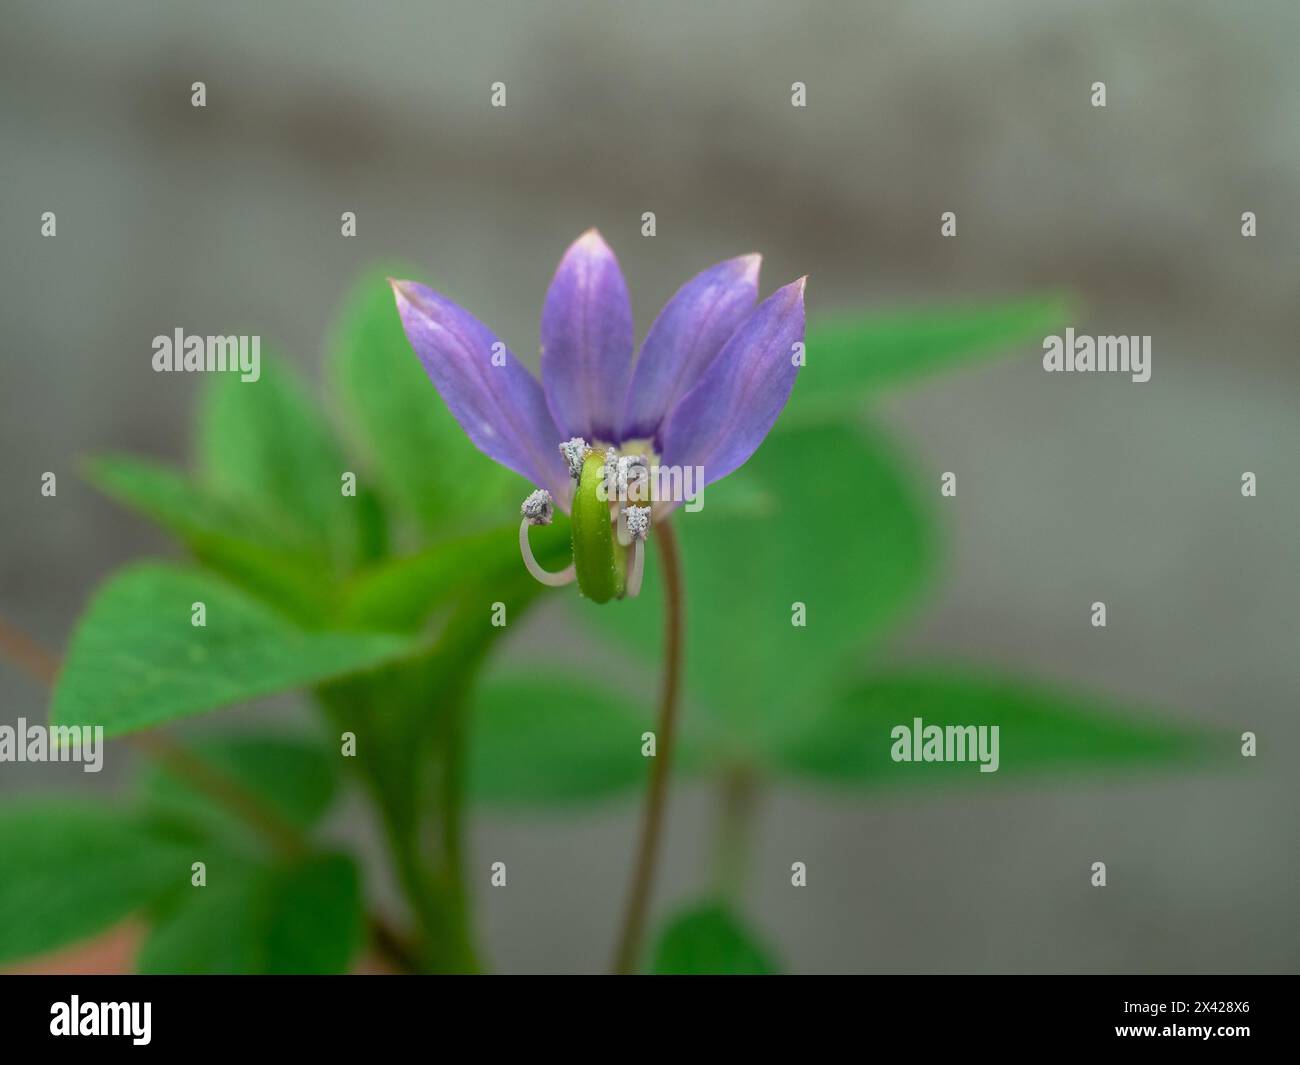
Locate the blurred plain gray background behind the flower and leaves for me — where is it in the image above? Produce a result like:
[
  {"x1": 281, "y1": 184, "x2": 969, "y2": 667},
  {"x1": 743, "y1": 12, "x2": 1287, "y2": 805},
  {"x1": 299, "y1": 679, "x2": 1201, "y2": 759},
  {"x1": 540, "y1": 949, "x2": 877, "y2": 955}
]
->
[{"x1": 0, "y1": 0, "x2": 1300, "y2": 971}]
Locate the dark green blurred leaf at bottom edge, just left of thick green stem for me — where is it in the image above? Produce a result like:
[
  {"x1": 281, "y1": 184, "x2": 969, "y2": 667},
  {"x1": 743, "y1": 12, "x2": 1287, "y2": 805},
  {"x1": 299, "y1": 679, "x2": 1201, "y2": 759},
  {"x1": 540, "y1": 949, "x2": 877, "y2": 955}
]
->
[{"x1": 138, "y1": 854, "x2": 364, "y2": 974}]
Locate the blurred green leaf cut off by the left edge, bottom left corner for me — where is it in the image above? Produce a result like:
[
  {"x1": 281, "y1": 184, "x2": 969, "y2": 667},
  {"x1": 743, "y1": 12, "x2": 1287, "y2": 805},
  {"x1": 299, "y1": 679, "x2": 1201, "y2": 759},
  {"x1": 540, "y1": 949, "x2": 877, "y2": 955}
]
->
[{"x1": 0, "y1": 800, "x2": 190, "y2": 961}]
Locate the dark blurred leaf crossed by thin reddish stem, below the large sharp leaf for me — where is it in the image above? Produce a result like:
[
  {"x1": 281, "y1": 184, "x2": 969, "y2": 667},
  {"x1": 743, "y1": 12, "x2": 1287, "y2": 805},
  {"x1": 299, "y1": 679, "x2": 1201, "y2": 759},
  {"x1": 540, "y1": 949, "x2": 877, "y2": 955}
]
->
[{"x1": 142, "y1": 733, "x2": 341, "y2": 832}]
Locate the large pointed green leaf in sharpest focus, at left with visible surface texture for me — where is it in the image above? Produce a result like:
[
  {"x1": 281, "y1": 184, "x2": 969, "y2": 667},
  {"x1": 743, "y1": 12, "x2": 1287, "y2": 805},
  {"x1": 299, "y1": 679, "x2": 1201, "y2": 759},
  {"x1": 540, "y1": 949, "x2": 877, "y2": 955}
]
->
[{"x1": 51, "y1": 563, "x2": 412, "y2": 735}]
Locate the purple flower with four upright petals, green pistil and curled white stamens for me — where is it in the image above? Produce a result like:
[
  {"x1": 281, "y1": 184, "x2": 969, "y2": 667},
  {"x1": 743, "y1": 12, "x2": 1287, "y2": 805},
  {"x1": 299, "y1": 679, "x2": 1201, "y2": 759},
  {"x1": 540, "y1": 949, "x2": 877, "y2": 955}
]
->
[{"x1": 393, "y1": 229, "x2": 806, "y2": 599}]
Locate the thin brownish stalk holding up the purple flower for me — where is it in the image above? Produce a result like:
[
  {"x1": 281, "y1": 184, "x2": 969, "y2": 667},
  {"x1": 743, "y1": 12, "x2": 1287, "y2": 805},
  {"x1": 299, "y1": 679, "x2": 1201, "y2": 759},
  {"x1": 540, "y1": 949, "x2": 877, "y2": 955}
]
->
[{"x1": 614, "y1": 521, "x2": 684, "y2": 975}]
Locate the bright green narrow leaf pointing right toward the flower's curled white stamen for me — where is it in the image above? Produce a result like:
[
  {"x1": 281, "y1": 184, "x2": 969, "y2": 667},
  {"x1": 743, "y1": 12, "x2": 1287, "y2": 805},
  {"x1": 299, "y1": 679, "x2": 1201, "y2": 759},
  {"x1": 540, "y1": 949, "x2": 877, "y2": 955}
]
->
[{"x1": 341, "y1": 514, "x2": 569, "y2": 632}]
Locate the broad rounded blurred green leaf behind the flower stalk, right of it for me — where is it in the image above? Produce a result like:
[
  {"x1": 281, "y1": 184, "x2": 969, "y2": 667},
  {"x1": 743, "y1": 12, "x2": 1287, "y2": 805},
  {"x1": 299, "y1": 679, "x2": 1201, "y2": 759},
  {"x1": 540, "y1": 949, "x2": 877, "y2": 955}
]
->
[{"x1": 579, "y1": 425, "x2": 933, "y2": 759}]
